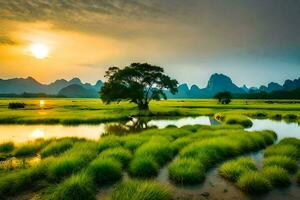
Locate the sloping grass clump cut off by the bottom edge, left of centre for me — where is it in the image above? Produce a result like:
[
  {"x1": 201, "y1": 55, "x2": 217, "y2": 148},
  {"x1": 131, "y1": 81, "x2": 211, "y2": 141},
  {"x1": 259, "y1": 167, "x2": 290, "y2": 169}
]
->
[{"x1": 45, "y1": 173, "x2": 96, "y2": 200}]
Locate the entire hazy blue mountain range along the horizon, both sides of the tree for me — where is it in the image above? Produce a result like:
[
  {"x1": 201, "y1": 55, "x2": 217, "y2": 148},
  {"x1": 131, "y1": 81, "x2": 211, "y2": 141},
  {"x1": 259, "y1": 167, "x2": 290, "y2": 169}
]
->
[{"x1": 0, "y1": 73, "x2": 300, "y2": 98}]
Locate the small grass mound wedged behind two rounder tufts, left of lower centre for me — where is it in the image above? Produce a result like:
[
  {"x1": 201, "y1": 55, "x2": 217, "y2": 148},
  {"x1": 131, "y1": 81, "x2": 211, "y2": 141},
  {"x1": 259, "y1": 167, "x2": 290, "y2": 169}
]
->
[{"x1": 99, "y1": 147, "x2": 132, "y2": 166}]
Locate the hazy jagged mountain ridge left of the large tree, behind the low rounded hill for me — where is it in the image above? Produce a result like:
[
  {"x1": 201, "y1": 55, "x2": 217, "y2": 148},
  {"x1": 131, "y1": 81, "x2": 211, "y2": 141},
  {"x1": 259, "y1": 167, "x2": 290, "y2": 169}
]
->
[{"x1": 0, "y1": 77, "x2": 103, "y2": 95}]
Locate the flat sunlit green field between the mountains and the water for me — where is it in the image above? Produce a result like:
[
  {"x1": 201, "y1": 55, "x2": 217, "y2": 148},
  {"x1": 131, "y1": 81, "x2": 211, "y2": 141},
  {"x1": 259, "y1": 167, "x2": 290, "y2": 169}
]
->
[{"x1": 0, "y1": 99, "x2": 300, "y2": 124}]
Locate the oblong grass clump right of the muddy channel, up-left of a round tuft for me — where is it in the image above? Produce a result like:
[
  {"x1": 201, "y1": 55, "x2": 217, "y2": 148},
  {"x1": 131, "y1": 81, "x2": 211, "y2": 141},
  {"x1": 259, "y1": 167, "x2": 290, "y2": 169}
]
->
[{"x1": 219, "y1": 157, "x2": 256, "y2": 182}]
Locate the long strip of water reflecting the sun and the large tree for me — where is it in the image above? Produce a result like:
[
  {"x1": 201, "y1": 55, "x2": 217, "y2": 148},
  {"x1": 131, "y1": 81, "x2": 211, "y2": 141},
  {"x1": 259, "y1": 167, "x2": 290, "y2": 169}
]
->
[{"x1": 0, "y1": 116, "x2": 216, "y2": 143}]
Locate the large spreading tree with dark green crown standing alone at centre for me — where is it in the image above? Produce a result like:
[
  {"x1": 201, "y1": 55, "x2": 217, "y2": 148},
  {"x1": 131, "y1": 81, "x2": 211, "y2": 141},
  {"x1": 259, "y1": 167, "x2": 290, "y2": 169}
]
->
[{"x1": 100, "y1": 63, "x2": 178, "y2": 110}]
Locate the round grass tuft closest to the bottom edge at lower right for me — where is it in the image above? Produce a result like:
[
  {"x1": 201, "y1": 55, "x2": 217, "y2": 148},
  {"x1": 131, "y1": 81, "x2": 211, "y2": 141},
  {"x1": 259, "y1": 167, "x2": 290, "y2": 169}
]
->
[{"x1": 237, "y1": 171, "x2": 271, "y2": 194}]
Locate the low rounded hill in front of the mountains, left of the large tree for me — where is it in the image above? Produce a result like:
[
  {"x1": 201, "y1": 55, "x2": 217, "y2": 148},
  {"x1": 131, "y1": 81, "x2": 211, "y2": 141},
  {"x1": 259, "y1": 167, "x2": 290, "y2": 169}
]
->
[{"x1": 58, "y1": 84, "x2": 99, "y2": 98}]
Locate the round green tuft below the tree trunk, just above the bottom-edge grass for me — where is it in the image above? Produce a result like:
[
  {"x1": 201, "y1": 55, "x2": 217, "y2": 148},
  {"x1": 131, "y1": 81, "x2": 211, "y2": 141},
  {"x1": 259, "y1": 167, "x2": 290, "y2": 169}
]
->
[{"x1": 129, "y1": 157, "x2": 159, "y2": 178}]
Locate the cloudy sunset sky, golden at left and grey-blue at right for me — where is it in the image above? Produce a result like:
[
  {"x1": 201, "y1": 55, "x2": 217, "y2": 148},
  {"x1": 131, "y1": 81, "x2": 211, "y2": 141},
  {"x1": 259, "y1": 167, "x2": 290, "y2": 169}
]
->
[{"x1": 0, "y1": 0, "x2": 300, "y2": 87}]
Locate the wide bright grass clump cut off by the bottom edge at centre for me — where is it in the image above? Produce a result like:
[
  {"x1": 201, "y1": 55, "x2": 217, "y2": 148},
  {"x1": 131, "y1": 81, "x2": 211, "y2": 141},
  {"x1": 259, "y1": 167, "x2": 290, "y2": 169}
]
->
[{"x1": 110, "y1": 180, "x2": 173, "y2": 200}]
